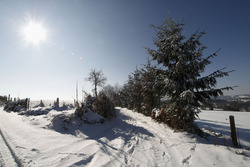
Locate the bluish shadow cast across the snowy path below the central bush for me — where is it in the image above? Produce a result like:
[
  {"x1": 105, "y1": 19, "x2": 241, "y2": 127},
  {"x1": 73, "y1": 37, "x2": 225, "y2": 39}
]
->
[{"x1": 50, "y1": 109, "x2": 154, "y2": 166}]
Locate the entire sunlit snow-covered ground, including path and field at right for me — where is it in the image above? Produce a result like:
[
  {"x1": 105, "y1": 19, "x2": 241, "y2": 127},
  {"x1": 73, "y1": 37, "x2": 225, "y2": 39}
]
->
[{"x1": 0, "y1": 107, "x2": 250, "y2": 167}]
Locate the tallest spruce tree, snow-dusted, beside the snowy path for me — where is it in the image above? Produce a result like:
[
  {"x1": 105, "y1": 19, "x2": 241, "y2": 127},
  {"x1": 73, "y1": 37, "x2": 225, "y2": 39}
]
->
[{"x1": 146, "y1": 17, "x2": 232, "y2": 130}]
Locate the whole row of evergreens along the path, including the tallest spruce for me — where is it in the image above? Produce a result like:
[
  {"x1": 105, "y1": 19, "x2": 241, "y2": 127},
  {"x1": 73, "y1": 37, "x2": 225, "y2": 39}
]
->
[{"x1": 101, "y1": 17, "x2": 236, "y2": 131}]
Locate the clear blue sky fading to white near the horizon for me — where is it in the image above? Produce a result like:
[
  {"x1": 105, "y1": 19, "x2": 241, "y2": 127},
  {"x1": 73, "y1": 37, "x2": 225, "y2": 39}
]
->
[{"x1": 0, "y1": 0, "x2": 250, "y2": 100}]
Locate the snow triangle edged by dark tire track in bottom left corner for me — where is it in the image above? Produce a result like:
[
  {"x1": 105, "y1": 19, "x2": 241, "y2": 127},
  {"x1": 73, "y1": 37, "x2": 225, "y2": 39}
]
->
[{"x1": 0, "y1": 129, "x2": 23, "y2": 167}]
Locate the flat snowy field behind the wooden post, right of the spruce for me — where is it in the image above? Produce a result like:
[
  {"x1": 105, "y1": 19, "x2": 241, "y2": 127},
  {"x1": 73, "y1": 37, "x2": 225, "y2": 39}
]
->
[{"x1": 196, "y1": 111, "x2": 250, "y2": 150}]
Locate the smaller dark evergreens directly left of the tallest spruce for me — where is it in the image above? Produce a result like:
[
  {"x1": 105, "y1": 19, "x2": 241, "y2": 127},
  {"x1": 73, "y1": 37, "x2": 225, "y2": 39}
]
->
[{"x1": 120, "y1": 61, "x2": 163, "y2": 116}]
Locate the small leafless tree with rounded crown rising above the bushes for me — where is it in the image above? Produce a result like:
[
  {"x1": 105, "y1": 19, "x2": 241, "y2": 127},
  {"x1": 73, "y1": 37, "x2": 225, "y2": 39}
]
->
[{"x1": 87, "y1": 69, "x2": 107, "y2": 97}]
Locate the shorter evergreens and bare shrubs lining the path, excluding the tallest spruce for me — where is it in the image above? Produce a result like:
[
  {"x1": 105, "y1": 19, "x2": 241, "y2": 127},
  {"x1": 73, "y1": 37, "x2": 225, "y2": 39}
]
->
[{"x1": 101, "y1": 60, "x2": 165, "y2": 116}]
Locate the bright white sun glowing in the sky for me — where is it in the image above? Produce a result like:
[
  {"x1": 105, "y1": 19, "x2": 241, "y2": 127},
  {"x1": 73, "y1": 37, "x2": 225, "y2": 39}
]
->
[{"x1": 22, "y1": 21, "x2": 46, "y2": 45}]
